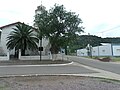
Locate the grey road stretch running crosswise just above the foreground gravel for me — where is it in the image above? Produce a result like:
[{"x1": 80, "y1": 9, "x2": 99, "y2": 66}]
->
[{"x1": 0, "y1": 65, "x2": 95, "y2": 76}]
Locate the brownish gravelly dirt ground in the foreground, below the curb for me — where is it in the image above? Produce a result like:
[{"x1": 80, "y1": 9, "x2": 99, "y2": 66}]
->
[{"x1": 0, "y1": 76, "x2": 120, "y2": 90}]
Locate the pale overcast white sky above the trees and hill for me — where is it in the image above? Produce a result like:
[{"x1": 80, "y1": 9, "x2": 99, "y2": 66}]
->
[{"x1": 0, "y1": 0, "x2": 120, "y2": 37}]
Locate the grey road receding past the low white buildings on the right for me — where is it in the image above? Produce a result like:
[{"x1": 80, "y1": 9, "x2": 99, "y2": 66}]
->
[{"x1": 68, "y1": 56, "x2": 120, "y2": 74}]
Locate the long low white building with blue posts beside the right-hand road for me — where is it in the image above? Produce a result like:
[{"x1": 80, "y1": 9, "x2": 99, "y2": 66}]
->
[{"x1": 77, "y1": 43, "x2": 120, "y2": 56}]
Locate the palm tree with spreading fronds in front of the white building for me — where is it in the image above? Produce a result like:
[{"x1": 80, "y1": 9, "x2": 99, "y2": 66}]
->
[{"x1": 6, "y1": 23, "x2": 38, "y2": 56}]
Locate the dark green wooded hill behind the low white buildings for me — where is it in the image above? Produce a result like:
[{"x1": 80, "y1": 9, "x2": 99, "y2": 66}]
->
[{"x1": 69, "y1": 35, "x2": 120, "y2": 52}]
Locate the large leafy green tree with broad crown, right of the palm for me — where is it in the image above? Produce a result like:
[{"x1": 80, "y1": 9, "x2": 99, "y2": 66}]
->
[{"x1": 35, "y1": 4, "x2": 83, "y2": 54}]
